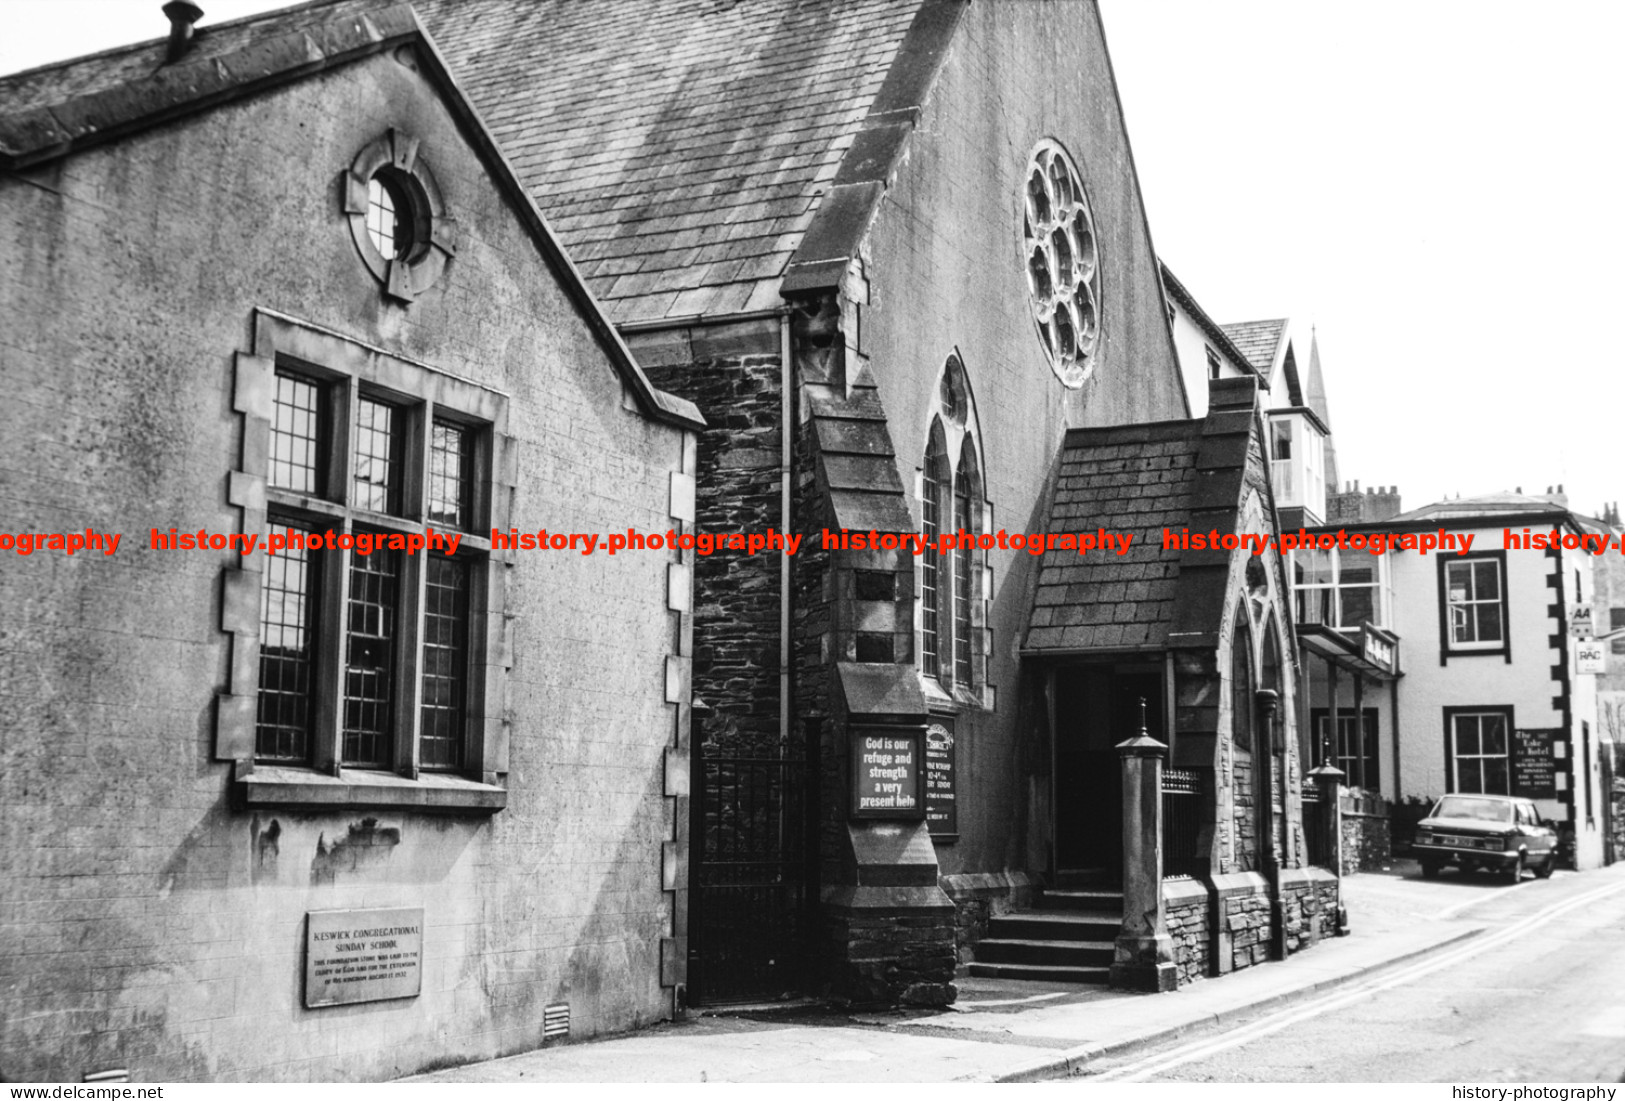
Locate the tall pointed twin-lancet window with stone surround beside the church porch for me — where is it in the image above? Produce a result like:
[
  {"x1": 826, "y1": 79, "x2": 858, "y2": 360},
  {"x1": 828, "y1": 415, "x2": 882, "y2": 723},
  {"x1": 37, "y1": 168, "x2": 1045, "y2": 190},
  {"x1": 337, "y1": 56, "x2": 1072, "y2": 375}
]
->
[{"x1": 913, "y1": 355, "x2": 995, "y2": 715}]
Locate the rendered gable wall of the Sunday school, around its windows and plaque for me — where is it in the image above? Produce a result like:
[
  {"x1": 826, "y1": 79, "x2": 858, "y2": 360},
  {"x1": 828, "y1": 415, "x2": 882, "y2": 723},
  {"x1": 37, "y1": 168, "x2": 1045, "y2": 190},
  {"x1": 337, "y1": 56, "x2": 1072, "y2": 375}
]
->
[{"x1": 0, "y1": 57, "x2": 683, "y2": 1082}]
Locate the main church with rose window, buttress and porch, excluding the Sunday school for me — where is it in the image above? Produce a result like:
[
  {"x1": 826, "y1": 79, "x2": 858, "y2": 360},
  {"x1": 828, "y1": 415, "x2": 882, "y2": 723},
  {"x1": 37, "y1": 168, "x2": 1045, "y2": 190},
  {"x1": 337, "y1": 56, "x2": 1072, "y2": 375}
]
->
[{"x1": 423, "y1": 0, "x2": 1336, "y2": 1004}]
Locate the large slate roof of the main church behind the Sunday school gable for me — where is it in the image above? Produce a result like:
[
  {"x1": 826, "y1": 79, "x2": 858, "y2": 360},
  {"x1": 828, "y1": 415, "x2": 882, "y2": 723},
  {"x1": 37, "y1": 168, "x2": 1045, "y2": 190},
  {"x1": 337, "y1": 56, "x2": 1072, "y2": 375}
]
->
[{"x1": 418, "y1": 0, "x2": 923, "y2": 322}]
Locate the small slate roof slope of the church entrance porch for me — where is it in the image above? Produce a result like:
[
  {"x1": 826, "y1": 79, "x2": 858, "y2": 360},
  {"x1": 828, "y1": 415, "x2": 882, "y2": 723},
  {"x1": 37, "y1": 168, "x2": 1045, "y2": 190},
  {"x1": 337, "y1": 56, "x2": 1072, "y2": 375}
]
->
[{"x1": 1024, "y1": 421, "x2": 1203, "y2": 653}]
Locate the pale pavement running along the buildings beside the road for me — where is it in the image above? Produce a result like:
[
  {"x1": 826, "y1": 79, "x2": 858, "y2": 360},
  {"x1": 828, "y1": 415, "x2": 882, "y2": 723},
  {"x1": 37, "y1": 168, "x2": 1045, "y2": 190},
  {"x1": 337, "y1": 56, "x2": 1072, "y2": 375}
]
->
[{"x1": 408, "y1": 861, "x2": 1537, "y2": 1082}]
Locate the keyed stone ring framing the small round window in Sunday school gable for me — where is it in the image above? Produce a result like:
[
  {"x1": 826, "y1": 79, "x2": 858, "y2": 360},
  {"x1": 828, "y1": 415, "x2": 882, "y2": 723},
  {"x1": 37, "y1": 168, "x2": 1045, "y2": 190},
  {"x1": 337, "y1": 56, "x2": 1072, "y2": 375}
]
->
[{"x1": 341, "y1": 127, "x2": 457, "y2": 302}]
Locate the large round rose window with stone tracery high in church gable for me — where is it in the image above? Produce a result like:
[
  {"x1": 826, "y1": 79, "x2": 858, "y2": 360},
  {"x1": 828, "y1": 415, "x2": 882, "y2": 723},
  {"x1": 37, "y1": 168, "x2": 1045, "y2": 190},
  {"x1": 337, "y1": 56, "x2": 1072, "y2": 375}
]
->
[{"x1": 1022, "y1": 140, "x2": 1100, "y2": 388}]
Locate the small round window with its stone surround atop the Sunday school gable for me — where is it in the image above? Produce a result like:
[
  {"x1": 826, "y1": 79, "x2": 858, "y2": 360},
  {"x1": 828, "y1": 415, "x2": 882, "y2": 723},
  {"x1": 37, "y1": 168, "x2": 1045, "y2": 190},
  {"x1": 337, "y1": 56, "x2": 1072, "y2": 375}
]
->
[{"x1": 345, "y1": 130, "x2": 457, "y2": 302}]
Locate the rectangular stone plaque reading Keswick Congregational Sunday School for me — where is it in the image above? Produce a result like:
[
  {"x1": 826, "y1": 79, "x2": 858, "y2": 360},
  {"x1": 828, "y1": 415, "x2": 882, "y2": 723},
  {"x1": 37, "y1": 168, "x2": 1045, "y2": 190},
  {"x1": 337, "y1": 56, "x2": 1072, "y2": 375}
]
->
[{"x1": 306, "y1": 906, "x2": 423, "y2": 1008}]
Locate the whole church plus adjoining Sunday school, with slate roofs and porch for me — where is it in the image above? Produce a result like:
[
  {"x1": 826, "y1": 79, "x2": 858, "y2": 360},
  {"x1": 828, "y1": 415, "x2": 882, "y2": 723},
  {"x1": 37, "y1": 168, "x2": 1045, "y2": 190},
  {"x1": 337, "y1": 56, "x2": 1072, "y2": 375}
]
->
[{"x1": 0, "y1": 0, "x2": 1339, "y2": 1080}]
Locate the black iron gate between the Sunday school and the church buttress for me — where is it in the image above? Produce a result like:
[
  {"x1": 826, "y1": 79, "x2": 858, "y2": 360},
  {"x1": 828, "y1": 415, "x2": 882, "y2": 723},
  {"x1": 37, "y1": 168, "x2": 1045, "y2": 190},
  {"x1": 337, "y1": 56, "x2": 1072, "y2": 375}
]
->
[{"x1": 689, "y1": 745, "x2": 814, "y2": 1005}]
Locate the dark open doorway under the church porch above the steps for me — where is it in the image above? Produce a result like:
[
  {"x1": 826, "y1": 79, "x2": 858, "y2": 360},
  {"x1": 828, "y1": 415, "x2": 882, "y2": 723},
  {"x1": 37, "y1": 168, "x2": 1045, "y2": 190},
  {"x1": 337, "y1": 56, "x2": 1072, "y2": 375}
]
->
[{"x1": 1055, "y1": 663, "x2": 1164, "y2": 883}]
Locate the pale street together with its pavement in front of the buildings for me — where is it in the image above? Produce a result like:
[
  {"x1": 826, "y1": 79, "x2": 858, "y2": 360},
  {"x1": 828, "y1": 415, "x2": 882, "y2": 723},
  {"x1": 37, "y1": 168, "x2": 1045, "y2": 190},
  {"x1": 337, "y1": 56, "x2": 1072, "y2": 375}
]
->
[{"x1": 403, "y1": 861, "x2": 1625, "y2": 1083}]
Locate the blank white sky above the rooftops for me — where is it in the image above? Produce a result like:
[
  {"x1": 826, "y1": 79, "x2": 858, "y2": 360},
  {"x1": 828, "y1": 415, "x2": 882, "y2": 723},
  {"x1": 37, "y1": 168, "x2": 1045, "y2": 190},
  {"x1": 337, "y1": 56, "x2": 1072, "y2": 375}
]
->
[{"x1": 0, "y1": 0, "x2": 1625, "y2": 513}]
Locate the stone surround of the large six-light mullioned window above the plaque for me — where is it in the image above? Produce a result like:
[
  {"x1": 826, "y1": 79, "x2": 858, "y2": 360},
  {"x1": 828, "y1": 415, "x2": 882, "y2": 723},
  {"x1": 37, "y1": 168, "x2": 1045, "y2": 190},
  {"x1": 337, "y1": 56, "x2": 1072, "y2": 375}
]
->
[{"x1": 215, "y1": 309, "x2": 514, "y2": 814}]
